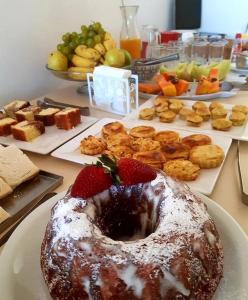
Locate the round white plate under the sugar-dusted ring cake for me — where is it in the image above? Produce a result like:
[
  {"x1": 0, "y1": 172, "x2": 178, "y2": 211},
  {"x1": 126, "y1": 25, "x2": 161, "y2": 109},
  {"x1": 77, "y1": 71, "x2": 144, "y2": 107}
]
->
[{"x1": 0, "y1": 193, "x2": 248, "y2": 300}]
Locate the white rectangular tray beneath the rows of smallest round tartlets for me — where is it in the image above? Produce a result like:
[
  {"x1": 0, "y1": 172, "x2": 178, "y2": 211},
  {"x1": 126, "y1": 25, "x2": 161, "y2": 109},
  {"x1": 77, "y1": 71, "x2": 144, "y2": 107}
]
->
[{"x1": 123, "y1": 96, "x2": 248, "y2": 141}]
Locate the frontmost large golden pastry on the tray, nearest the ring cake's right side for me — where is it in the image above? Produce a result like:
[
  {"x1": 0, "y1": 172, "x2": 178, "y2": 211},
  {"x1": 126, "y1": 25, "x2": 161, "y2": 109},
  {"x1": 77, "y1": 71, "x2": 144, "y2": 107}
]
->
[{"x1": 163, "y1": 159, "x2": 200, "y2": 181}]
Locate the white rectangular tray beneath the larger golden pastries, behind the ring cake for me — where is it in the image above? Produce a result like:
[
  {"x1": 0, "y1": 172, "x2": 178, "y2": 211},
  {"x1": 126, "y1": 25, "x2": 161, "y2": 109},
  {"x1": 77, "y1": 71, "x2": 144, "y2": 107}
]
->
[{"x1": 51, "y1": 118, "x2": 232, "y2": 195}]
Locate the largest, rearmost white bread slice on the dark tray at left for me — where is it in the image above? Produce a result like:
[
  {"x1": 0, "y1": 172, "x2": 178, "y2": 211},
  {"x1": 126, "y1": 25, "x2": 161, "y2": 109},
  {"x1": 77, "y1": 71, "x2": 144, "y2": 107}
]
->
[{"x1": 0, "y1": 144, "x2": 39, "y2": 189}]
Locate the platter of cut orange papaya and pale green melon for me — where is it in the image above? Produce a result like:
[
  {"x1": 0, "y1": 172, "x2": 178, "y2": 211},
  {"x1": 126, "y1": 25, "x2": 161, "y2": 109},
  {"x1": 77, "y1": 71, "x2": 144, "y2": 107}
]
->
[{"x1": 139, "y1": 60, "x2": 236, "y2": 100}]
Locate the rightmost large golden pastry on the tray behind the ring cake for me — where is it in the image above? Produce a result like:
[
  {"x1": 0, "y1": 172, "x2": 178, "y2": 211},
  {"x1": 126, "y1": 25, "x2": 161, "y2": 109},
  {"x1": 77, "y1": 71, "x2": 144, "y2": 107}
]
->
[{"x1": 189, "y1": 145, "x2": 225, "y2": 169}]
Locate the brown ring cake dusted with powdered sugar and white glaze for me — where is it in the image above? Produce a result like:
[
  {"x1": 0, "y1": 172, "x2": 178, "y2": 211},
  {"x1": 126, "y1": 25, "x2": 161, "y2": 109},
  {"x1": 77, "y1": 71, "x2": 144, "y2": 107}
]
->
[{"x1": 41, "y1": 174, "x2": 223, "y2": 299}]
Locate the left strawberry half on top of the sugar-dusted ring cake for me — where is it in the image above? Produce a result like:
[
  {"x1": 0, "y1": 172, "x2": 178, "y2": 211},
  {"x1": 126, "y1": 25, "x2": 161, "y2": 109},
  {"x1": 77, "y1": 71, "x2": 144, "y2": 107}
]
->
[{"x1": 71, "y1": 165, "x2": 112, "y2": 199}]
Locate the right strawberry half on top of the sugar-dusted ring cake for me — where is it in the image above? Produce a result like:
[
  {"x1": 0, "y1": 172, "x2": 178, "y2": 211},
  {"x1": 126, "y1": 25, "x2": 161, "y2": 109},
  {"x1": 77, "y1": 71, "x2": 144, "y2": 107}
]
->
[{"x1": 117, "y1": 158, "x2": 157, "y2": 185}]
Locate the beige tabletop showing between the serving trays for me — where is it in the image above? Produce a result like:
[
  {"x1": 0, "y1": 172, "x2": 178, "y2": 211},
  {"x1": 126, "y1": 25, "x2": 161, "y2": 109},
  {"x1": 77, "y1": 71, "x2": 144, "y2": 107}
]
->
[{"x1": 0, "y1": 83, "x2": 248, "y2": 253}]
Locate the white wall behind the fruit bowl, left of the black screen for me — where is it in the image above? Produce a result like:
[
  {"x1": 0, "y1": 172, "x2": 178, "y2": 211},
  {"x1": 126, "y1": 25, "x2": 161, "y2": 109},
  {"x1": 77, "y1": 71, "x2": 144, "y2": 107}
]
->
[{"x1": 0, "y1": 0, "x2": 173, "y2": 104}]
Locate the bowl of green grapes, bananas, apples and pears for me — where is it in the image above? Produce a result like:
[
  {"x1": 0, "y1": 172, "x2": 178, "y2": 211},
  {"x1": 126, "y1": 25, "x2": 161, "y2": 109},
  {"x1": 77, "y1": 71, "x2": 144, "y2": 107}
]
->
[{"x1": 46, "y1": 22, "x2": 131, "y2": 81}]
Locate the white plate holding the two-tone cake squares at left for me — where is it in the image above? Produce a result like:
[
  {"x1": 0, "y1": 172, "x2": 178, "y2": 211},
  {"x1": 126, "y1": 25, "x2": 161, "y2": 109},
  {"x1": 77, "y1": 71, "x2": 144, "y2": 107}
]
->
[{"x1": 0, "y1": 117, "x2": 97, "y2": 154}]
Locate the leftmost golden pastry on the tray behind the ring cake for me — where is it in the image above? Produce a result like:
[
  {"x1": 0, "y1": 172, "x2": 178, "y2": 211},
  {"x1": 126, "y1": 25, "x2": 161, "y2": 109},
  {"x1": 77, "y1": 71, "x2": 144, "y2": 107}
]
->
[{"x1": 80, "y1": 135, "x2": 106, "y2": 155}]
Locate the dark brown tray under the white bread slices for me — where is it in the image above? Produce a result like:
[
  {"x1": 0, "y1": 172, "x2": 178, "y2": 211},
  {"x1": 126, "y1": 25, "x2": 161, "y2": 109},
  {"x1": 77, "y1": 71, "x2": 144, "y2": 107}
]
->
[{"x1": 0, "y1": 171, "x2": 63, "y2": 235}]
